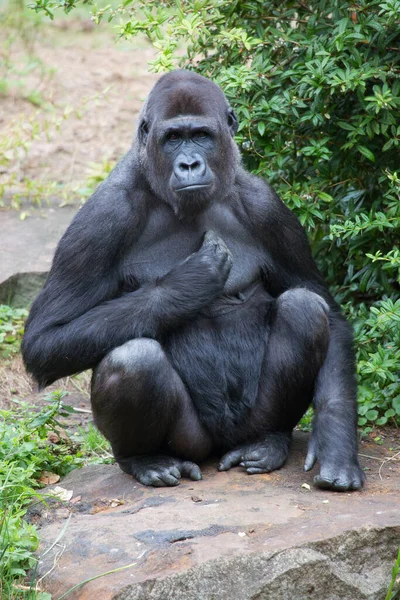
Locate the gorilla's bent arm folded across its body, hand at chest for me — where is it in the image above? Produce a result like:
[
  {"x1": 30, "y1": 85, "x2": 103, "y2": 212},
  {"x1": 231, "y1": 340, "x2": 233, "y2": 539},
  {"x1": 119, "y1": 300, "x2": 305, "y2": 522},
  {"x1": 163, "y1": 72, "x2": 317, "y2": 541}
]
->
[{"x1": 22, "y1": 193, "x2": 231, "y2": 386}]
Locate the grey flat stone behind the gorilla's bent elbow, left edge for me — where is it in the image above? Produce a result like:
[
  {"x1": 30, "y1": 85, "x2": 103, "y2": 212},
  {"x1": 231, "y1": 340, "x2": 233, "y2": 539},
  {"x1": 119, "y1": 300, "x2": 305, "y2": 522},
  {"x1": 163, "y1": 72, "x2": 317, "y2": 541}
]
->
[{"x1": 0, "y1": 205, "x2": 78, "y2": 308}]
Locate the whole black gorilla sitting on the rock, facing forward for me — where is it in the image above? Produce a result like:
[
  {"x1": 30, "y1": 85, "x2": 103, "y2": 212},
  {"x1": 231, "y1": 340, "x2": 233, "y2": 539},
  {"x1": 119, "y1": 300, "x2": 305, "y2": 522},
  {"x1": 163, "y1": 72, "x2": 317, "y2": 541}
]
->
[{"x1": 23, "y1": 71, "x2": 364, "y2": 491}]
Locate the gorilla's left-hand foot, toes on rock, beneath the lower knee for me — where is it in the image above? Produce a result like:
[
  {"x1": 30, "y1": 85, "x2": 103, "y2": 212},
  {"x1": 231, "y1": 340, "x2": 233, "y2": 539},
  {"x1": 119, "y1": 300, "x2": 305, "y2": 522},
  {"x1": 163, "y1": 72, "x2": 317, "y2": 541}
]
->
[{"x1": 117, "y1": 455, "x2": 202, "y2": 487}]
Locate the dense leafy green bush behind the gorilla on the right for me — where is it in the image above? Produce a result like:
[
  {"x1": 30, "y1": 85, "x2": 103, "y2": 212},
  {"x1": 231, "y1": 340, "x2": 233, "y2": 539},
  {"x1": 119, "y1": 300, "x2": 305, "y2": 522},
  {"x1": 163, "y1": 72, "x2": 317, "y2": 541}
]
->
[{"x1": 28, "y1": 0, "x2": 400, "y2": 425}]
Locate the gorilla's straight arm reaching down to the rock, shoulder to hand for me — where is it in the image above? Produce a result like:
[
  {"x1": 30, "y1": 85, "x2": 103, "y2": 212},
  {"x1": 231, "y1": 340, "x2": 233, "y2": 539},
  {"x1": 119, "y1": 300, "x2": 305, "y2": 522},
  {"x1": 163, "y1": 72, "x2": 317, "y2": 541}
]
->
[{"x1": 256, "y1": 185, "x2": 364, "y2": 490}]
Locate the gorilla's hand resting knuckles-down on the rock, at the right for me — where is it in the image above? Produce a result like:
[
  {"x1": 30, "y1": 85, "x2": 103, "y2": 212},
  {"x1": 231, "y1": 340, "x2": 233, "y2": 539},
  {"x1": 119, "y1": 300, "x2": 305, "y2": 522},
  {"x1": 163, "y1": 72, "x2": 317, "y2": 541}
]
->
[{"x1": 304, "y1": 418, "x2": 365, "y2": 492}]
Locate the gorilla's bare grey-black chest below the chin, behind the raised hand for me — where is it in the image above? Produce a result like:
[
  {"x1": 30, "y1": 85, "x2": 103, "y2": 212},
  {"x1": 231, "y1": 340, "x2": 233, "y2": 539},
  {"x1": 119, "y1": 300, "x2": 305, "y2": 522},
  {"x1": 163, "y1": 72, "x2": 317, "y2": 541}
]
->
[{"x1": 122, "y1": 207, "x2": 265, "y2": 293}]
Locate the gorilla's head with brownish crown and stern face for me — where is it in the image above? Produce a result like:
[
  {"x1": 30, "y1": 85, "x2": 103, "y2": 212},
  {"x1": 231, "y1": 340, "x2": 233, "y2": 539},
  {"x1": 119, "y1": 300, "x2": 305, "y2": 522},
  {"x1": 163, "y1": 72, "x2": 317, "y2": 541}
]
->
[{"x1": 137, "y1": 71, "x2": 240, "y2": 217}]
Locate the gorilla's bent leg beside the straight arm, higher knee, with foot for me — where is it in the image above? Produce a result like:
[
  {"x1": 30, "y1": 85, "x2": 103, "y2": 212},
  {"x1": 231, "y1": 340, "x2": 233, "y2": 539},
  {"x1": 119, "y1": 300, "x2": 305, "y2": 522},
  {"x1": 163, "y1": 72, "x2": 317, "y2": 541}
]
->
[{"x1": 218, "y1": 288, "x2": 329, "y2": 474}]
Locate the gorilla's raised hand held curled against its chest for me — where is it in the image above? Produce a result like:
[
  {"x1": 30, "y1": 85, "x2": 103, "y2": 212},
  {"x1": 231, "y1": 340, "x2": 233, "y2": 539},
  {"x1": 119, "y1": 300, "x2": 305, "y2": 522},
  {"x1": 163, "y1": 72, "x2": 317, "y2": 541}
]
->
[{"x1": 162, "y1": 231, "x2": 232, "y2": 310}]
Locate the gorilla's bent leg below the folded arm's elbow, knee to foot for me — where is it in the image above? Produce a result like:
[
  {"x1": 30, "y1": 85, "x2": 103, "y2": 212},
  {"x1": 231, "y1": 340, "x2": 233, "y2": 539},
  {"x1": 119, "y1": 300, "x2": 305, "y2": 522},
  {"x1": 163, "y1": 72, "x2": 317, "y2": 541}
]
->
[{"x1": 91, "y1": 338, "x2": 211, "y2": 486}]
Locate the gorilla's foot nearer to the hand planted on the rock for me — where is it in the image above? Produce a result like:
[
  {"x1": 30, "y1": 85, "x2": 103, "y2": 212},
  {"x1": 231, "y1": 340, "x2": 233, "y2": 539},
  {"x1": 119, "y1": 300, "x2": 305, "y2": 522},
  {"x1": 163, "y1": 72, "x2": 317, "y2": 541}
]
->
[{"x1": 218, "y1": 432, "x2": 292, "y2": 475}]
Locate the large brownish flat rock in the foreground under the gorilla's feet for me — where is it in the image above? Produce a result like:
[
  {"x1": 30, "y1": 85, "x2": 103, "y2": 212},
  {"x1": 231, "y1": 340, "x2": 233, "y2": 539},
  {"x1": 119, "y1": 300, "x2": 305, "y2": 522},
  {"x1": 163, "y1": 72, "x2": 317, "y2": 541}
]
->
[{"x1": 37, "y1": 432, "x2": 400, "y2": 600}]
